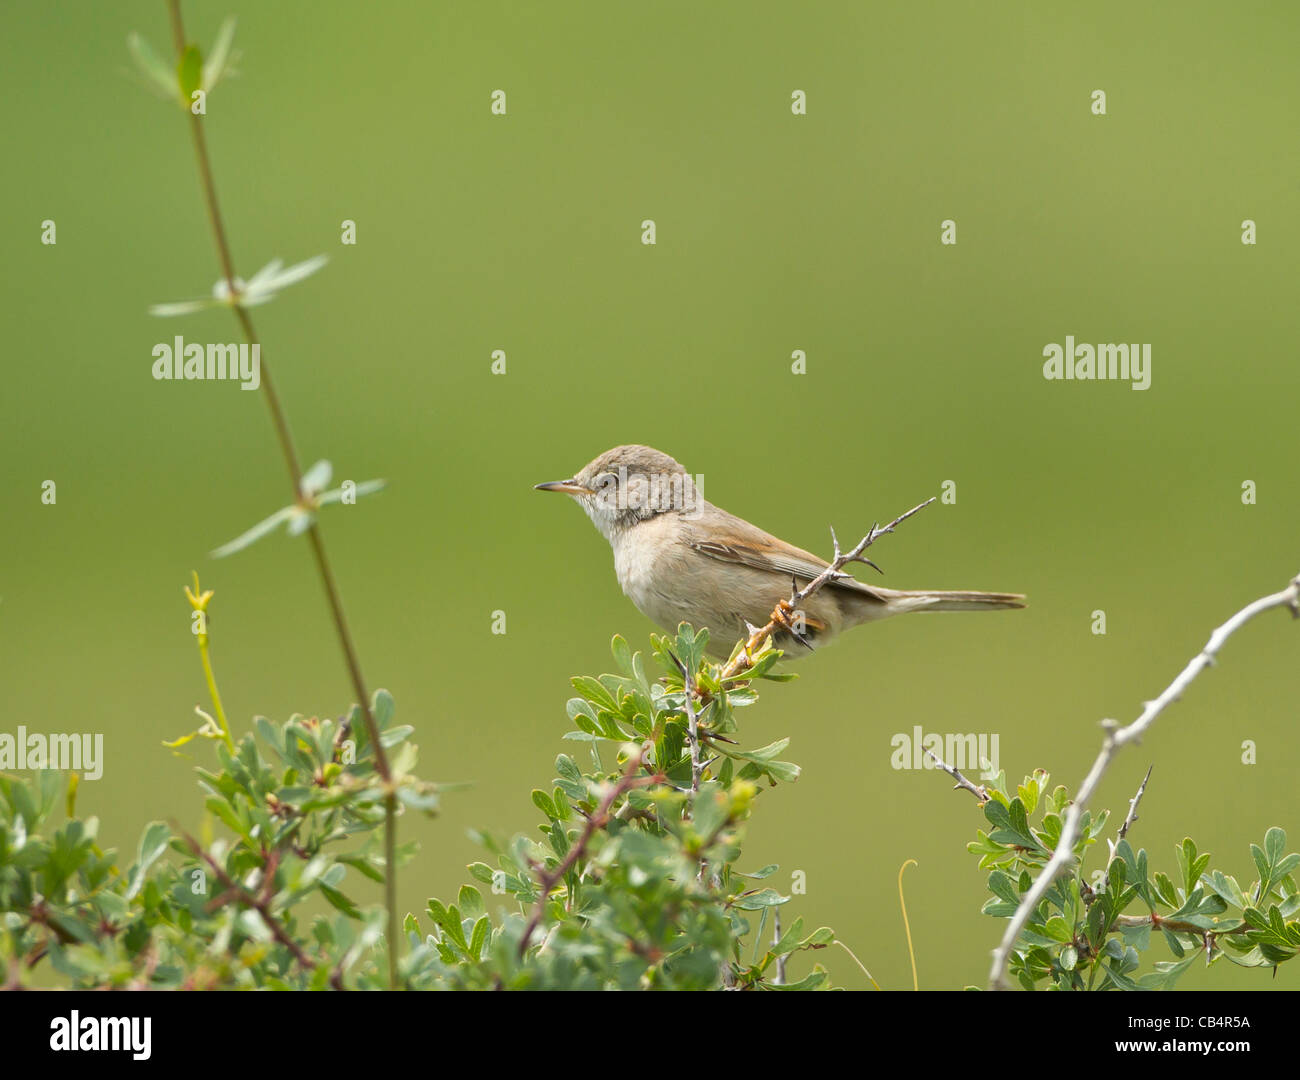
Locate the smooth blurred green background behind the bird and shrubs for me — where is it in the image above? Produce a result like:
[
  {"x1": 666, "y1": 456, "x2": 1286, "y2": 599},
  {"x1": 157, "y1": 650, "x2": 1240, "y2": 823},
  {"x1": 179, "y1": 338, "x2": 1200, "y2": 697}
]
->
[{"x1": 0, "y1": 0, "x2": 1300, "y2": 989}]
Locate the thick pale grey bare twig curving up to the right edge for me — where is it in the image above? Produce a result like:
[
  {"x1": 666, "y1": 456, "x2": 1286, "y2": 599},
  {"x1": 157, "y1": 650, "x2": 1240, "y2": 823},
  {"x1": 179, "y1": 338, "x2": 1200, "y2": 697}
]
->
[{"x1": 988, "y1": 576, "x2": 1300, "y2": 990}]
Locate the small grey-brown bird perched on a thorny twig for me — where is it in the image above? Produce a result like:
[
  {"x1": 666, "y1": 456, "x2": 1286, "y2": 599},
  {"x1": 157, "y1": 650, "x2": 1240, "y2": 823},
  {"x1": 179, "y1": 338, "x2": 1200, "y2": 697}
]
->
[{"x1": 536, "y1": 446, "x2": 1024, "y2": 659}]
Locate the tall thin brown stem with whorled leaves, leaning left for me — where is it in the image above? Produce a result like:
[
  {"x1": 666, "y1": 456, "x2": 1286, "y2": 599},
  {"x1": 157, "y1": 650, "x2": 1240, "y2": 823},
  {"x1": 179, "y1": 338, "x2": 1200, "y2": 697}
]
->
[{"x1": 168, "y1": 0, "x2": 400, "y2": 989}]
